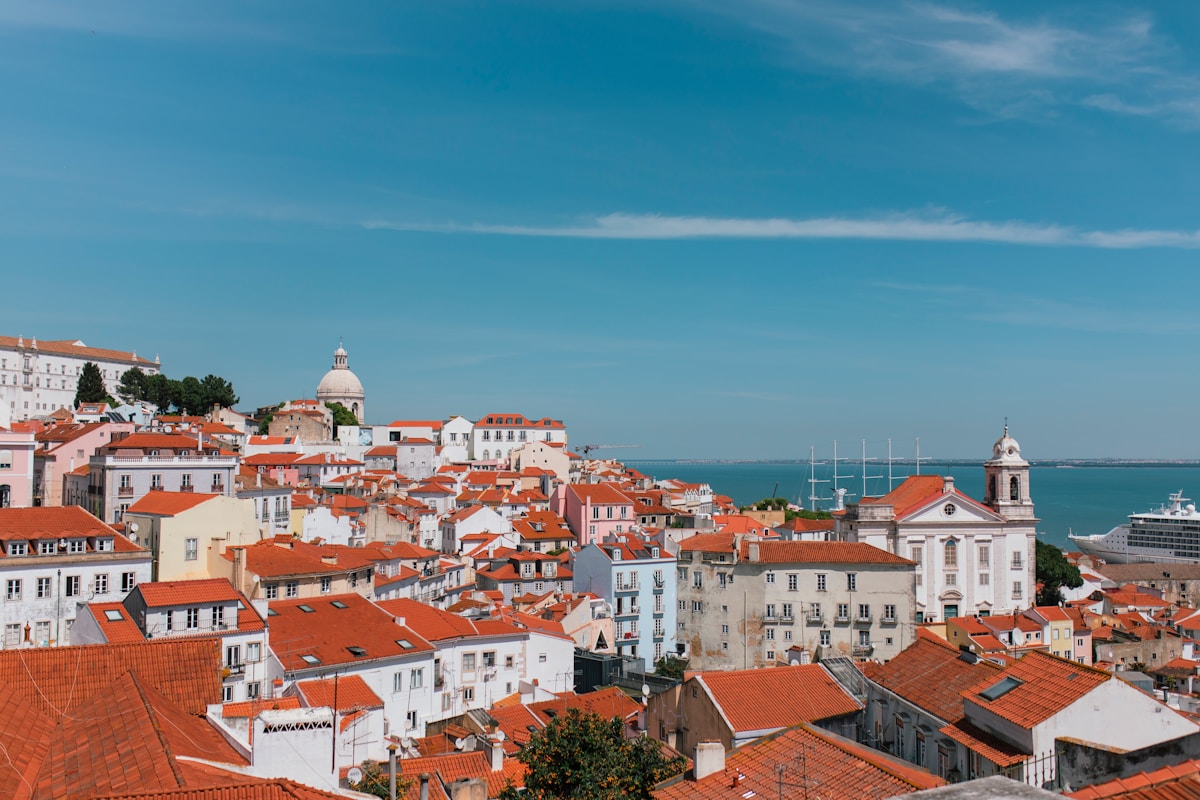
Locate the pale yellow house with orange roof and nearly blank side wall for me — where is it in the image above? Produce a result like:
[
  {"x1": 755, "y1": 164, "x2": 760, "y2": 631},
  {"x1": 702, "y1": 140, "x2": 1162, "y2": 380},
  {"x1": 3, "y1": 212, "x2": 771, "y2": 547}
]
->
[{"x1": 124, "y1": 492, "x2": 264, "y2": 581}]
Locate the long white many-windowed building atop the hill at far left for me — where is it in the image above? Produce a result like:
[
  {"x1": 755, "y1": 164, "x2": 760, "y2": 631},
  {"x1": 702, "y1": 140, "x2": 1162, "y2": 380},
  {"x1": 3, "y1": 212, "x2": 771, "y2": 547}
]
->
[{"x1": 0, "y1": 336, "x2": 161, "y2": 420}]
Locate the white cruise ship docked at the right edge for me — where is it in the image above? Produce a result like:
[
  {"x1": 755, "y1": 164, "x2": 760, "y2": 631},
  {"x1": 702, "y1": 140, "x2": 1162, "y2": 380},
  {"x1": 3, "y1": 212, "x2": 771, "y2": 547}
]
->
[{"x1": 1070, "y1": 491, "x2": 1200, "y2": 564}]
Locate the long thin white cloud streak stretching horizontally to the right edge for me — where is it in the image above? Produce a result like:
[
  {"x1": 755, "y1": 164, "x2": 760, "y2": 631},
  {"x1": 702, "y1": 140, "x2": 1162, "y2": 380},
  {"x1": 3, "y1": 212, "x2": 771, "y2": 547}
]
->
[{"x1": 362, "y1": 212, "x2": 1200, "y2": 249}]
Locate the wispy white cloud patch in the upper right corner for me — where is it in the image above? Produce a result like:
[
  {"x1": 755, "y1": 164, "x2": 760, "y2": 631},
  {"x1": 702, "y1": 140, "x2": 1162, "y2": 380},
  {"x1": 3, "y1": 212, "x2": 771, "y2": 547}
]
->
[{"x1": 680, "y1": 0, "x2": 1200, "y2": 126}]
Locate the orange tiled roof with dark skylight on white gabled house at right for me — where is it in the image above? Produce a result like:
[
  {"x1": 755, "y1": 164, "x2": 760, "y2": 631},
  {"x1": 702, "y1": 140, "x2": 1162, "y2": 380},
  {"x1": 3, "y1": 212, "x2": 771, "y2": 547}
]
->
[{"x1": 962, "y1": 650, "x2": 1114, "y2": 728}]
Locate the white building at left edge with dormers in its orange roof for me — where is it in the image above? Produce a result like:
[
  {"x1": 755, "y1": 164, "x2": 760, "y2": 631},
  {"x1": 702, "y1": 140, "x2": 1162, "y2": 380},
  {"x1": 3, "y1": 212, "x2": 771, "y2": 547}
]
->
[{"x1": 0, "y1": 506, "x2": 151, "y2": 649}]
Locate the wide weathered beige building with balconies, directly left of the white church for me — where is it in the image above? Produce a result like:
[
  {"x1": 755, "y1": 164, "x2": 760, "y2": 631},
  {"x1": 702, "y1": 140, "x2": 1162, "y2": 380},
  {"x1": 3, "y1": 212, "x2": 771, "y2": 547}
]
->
[{"x1": 676, "y1": 533, "x2": 916, "y2": 669}]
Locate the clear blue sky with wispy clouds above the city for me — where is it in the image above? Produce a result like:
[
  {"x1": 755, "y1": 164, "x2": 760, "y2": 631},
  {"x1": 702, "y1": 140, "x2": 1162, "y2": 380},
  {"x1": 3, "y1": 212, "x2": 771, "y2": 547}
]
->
[{"x1": 0, "y1": 0, "x2": 1200, "y2": 458}]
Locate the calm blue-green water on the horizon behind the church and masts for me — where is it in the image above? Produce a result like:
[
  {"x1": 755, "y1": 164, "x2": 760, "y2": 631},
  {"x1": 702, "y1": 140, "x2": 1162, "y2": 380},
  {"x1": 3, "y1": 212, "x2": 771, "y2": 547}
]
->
[{"x1": 629, "y1": 461, "x2": 1200, "y2": 547}]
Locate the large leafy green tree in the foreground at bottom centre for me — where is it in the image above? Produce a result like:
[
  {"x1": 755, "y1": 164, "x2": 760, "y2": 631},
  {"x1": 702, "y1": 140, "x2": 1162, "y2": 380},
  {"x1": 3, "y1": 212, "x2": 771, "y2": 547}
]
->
[{"x1": 499, "y1": 709, "x2": 688, "y2": 800}]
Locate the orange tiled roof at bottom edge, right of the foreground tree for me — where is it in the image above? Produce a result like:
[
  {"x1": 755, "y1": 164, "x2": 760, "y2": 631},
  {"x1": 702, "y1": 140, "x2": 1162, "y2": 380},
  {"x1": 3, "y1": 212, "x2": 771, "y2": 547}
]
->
[{"x1": 654, "y1": 724, "x2": 946, "y2": 800}]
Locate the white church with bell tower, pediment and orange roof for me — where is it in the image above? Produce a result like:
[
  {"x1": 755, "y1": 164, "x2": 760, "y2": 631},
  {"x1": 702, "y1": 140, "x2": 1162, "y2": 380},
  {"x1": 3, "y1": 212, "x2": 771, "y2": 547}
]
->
[{"x1": 834, "y1": 426, "x2": 1038, "y2": 622}]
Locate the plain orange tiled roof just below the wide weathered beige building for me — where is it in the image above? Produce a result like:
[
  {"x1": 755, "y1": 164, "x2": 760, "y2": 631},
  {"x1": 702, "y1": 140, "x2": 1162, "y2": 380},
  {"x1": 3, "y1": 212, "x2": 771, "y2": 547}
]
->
[{"x1": 692, "y1": 664, "x2": 863, "y2": 732}]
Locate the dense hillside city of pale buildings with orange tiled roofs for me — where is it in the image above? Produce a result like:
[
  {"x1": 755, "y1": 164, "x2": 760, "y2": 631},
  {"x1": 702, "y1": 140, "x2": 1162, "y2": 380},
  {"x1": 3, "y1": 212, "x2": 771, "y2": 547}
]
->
[{"x1": 0, "y1": 337, "x2": 1200, "y2": 799}]
